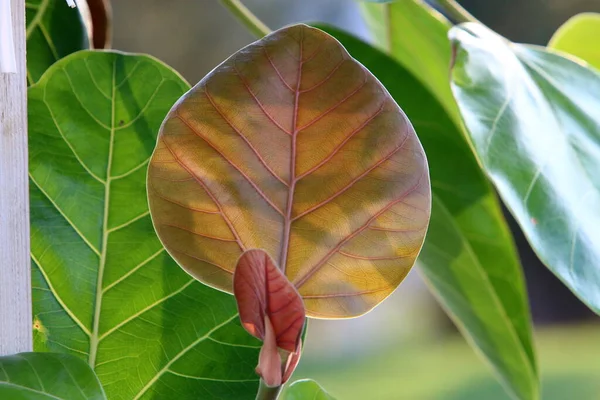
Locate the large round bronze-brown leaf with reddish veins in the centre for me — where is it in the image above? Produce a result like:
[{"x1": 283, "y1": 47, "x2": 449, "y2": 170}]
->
[{"x1": 148, "y1": 25, "x2": 430, "y2": 318}]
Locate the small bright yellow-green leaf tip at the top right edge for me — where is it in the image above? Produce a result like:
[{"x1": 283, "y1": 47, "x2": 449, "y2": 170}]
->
[{"x1": 548, "y1": 13, "x2": 600, "y2": 69}]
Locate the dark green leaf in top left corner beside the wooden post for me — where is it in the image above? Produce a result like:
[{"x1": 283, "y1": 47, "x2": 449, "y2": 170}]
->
[{"x1": 25, "y1": 0, "x2": 90, "y2": 85}]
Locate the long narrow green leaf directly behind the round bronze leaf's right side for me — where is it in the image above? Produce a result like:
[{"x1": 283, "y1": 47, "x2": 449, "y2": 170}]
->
[{"x1": 323, "y1": 27, "x2": 538, "y2": 399}]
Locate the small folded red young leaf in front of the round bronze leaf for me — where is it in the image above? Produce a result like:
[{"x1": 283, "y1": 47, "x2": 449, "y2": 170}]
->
[{"x1": 233, "y1": 249, "x2": 306, "y2": 353}]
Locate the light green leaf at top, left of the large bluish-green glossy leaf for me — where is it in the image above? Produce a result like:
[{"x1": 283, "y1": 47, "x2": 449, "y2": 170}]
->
[{"x1": 362, "y1": 0, "x2": 460, "y2": 124}]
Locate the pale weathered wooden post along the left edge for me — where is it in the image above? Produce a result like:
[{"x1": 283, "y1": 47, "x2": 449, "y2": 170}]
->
[{"x1": 0, "y1": 0, "x2": 33, "y2": 355}]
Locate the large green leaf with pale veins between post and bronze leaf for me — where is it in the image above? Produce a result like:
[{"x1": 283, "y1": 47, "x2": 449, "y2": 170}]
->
[{"x1": 28, "y1": 51, "x2": 260, "y2": 399}]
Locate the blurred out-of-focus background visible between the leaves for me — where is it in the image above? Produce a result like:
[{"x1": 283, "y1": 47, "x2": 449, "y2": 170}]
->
[{"x1": 113, "y1": 0, "x2": 600, "y2": 400}]
